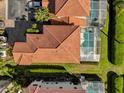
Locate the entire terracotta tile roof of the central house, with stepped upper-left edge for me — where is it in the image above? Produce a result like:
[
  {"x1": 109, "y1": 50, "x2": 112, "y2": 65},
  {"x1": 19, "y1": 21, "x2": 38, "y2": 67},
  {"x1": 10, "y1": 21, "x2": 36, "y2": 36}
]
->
[{"x1": 13, "y1": 25, "x2": 80, "y2": 65}]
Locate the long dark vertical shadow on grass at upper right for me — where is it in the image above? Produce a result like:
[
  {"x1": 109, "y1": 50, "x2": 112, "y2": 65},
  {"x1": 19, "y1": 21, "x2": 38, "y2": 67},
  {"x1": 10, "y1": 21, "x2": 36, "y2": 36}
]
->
[{"x1": 108, "y1": 0, "x2": 124, "y2": 65}]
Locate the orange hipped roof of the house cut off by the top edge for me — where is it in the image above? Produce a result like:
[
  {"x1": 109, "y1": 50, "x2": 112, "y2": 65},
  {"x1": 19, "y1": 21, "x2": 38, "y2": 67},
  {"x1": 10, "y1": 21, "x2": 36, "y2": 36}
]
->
[{"x1": 42, "y1": 0, "x2": 90, "y2": 16}]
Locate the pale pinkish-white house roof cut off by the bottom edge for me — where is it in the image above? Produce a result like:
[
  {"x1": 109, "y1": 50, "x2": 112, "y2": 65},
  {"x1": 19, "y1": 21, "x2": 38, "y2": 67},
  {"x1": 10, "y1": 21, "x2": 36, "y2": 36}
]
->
[{"x1": 23, "y1": 81, "x2": 87, "y2": 93}]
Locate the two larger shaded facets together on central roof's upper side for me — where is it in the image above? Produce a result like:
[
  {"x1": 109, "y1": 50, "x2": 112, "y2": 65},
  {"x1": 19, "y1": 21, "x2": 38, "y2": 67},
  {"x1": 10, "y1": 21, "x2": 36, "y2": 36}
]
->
[{"x1": 27, "y1": 25, "x2": 78, "y2": 48}]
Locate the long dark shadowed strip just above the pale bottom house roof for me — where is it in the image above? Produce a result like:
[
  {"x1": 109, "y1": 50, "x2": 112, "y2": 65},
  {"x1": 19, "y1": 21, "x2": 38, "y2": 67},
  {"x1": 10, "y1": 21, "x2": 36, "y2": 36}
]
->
[{"x1": 13, "y1": 72, "x2": 79, "y2": 88}]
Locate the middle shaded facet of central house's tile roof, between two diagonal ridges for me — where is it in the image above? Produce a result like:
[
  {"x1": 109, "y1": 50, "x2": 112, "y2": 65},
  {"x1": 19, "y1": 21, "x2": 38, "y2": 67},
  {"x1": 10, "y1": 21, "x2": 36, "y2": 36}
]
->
[{"x1": 27, "y1": 31, "x2": 59, "y2": 48}]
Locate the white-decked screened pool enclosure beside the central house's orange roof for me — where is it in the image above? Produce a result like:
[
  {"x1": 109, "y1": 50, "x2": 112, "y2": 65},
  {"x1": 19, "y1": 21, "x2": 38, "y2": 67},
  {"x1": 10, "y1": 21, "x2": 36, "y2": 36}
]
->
[{"x1": 80, "y1": 27, "x2": 100, "y2": 62}]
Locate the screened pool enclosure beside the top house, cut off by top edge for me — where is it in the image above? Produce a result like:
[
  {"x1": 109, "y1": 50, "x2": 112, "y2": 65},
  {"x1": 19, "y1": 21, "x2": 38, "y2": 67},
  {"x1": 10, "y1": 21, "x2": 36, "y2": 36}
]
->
[{"x1": 88, "y1": 0, "x2": 107, "y2": 24}]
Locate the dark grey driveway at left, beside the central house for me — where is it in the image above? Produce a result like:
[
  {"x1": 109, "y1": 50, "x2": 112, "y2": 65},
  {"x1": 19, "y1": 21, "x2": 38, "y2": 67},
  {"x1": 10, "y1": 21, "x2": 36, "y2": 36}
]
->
[{"x1": 5, "y1": 20, "x2": 32, "y2": 45}]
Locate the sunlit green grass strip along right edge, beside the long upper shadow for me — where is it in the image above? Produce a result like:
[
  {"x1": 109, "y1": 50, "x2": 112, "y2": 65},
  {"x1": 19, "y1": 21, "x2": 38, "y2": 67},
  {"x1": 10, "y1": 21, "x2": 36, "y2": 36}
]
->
[{"x1": 112, "y1": 0, "x2": 124, "y2": 65}]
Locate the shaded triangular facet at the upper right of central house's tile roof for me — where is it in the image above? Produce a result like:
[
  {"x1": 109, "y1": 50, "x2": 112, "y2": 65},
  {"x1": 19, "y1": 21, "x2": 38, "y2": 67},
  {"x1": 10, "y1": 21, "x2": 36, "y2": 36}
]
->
[{"x1": 44, "y1": 25, "x2": 78, "y2": 43}]
